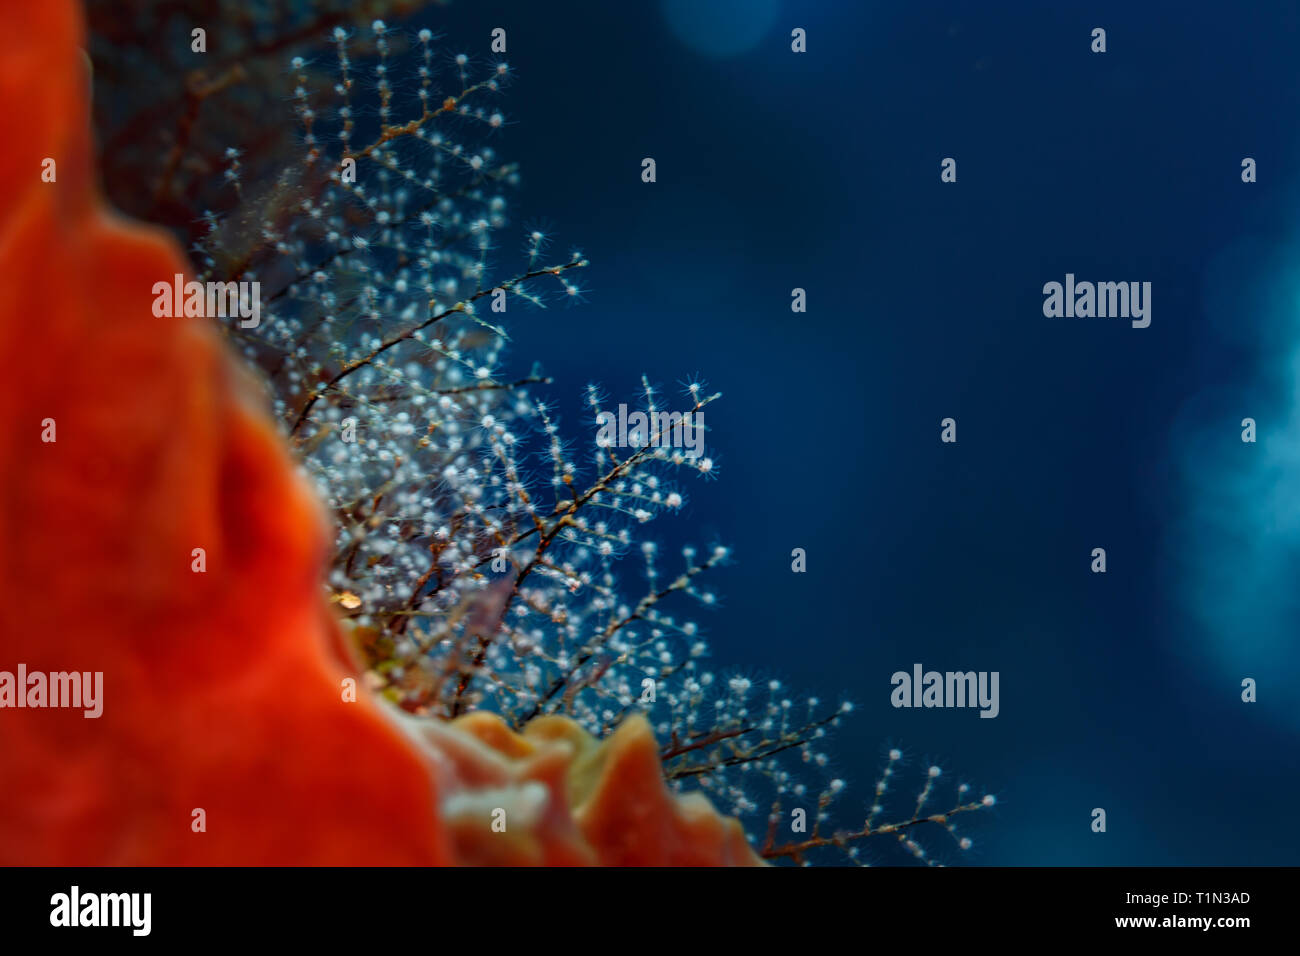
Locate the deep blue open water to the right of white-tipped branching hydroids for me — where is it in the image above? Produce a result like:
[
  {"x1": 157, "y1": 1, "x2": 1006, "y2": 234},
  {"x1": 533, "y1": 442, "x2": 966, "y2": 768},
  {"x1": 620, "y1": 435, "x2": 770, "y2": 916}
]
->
[{"x1": 428, "y1": 0, "x2": 1300, "y2": 865}]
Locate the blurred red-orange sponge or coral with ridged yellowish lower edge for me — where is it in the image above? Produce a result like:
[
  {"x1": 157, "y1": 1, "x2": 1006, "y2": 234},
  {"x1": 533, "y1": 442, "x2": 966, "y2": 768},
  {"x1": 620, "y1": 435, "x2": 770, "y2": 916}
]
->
[{"x1": 0, "y1": 0, "x2": 755, "y2": 865}]
